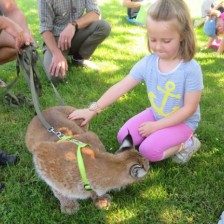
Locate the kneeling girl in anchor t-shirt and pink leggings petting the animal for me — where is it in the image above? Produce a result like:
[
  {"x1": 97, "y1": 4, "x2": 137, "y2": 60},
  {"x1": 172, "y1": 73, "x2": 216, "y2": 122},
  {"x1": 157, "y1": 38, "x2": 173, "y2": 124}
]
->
[{"x1": 68, "y1": 0, "x2": 203, "y2": 163}]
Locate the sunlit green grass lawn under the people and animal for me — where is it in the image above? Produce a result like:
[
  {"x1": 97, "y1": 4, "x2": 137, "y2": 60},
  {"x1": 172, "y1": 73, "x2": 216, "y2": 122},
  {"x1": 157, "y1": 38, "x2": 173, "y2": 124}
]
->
[{"x1": 0, "y1": 0, "x2": 224, "y2": 224}]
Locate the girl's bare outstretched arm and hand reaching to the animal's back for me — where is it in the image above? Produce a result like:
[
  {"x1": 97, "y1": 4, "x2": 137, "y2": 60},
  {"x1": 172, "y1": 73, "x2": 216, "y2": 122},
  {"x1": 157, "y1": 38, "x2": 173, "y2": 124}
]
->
[{"x1": 68, "y1": 75, "x2": 139, "y2": 126}]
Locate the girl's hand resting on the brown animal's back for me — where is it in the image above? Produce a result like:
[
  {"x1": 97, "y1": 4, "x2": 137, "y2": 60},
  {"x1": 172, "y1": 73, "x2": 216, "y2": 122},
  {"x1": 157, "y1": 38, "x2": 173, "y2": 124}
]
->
[{"x1": 68, "y1": 109, "x2": 97, "y2": 127}]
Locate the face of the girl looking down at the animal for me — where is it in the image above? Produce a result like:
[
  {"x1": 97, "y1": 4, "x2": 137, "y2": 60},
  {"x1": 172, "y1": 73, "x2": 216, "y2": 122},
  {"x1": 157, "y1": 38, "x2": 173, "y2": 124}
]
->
[{"x1": 147, "y1": 16, "x2": 181, "y2": 60}]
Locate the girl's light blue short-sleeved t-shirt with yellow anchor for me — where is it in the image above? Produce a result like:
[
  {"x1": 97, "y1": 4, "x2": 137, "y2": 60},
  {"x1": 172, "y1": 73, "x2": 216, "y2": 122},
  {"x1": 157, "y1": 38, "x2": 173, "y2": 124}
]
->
[{"x1": 130, "y1": 54, "x2": 203, "y2": 130}]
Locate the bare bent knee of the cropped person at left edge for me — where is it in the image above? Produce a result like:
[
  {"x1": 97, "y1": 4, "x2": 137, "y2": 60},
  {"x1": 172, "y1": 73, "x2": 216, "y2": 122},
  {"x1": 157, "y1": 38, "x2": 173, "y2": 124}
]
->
[{"x1": 0, "y1": 31, "x2": 17, "y2": 64}]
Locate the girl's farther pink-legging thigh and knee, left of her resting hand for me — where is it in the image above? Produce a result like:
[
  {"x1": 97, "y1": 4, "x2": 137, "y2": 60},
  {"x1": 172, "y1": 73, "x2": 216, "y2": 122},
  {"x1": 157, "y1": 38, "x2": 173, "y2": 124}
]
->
[{"x1": 117, "y1": 108, "x2": 155, "y2": 145}]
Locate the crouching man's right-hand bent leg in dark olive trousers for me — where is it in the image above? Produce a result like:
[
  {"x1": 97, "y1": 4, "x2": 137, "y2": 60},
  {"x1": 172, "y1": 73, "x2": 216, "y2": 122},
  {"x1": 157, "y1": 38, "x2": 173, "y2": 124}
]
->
[{"x1": 69, "y1": 20, "x2": 111, "y2": 59}]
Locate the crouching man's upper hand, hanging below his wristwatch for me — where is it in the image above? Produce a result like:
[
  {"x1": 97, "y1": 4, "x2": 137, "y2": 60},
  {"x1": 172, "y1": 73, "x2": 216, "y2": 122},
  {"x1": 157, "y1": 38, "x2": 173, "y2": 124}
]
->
[{"x1": 58, "y1": 23, "x2": 75, "y2": 51}]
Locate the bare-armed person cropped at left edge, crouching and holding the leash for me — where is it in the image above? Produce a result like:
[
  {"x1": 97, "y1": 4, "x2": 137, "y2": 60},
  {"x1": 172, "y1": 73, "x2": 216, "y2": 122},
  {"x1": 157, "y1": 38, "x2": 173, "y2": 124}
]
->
[{"x1": 0, "y1": 0, "x2": 33, "y2": 87}]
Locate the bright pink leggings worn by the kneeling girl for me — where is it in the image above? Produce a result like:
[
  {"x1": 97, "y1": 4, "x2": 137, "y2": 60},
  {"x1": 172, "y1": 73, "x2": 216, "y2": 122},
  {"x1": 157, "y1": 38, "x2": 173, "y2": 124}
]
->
[{"x1": 117, "y1": 108, "x2": 193, "y2": 162}]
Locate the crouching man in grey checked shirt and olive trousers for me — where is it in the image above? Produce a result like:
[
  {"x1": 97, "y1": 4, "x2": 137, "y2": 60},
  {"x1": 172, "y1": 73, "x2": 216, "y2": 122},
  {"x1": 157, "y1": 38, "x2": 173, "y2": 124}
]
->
[{"x1": 38, "y1": 0, "x2": 111, "y2": 82}]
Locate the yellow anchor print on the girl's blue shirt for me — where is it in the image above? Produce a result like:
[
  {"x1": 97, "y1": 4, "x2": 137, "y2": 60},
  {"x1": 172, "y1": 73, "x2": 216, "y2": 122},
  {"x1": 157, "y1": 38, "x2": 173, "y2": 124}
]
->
[{"x1": 148, "y1": 81, "x2": 180, "y2": 117}]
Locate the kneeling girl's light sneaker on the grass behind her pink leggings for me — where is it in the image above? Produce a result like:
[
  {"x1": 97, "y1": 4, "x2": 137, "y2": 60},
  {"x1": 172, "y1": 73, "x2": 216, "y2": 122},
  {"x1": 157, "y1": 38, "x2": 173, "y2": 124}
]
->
[{"x1": 172, "y1": 136, "x2": 201, "y2": 163}]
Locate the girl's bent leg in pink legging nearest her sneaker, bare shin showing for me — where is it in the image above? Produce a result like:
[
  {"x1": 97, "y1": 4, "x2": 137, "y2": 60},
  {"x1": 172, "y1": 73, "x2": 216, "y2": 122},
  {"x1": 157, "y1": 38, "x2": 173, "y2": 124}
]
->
[{"x1": 139, "y1": 123, "x2": 193, "y2": 162}]
